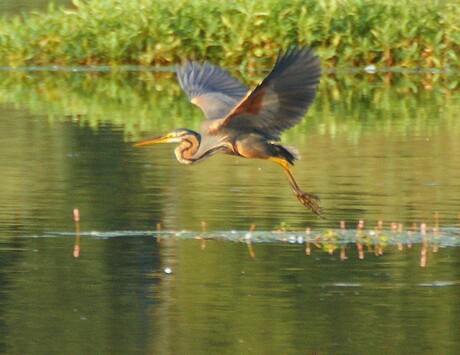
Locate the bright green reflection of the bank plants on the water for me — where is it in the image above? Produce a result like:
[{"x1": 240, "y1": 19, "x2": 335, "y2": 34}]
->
[{"x1": 0, "y1": 71, "x2": 460, "y2": 143}]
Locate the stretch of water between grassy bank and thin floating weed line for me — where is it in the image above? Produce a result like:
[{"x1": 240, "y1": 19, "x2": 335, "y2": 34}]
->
[{"x1": 0, "y1": 71, "x2": 460, "y2": 230}]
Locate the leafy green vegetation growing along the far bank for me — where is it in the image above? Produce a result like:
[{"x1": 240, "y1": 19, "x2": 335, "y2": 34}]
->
[{"x1": 0, "y1": 0, "x2": 460, "y2": 68}]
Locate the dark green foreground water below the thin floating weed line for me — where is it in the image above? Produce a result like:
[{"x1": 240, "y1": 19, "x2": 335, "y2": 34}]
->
[{"x1": 0, "y1": 237, "x2": 459, "y2": 353}]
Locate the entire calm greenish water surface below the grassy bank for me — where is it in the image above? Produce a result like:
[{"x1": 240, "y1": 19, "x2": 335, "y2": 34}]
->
[{"x1": 0, "y1": 68, "x2": 460, "y2": 354}]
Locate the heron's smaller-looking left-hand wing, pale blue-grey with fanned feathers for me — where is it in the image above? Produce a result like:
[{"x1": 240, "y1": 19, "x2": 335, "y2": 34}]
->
[{"x1": 177, "y1": 61, "x2": 248, "y2": 120}]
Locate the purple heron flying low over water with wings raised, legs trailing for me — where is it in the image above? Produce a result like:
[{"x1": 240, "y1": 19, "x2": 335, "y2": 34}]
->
[{"x1": 135, "y1": 47, "x2": 322, "y2": 217}]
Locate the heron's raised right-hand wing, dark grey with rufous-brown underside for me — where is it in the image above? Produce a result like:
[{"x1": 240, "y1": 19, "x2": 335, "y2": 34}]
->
[{"x1": 218, "y1": 47, "x2": 321, "y2": 137}]
